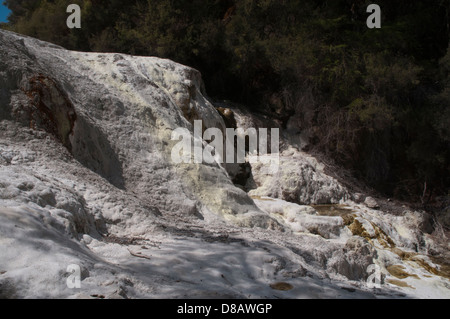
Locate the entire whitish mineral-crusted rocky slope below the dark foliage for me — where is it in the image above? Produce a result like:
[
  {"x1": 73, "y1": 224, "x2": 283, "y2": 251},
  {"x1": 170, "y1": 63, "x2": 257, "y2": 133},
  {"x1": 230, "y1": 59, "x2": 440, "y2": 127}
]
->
[{"x1": 0, "y1": 31, "x2": 450, "y2": 298}]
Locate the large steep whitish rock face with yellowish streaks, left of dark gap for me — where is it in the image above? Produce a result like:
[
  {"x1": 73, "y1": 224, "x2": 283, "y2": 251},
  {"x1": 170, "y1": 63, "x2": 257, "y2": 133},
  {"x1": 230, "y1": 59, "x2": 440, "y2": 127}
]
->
[{"x1": 1, "y1": 28, "x2": 276, "y2": 227}]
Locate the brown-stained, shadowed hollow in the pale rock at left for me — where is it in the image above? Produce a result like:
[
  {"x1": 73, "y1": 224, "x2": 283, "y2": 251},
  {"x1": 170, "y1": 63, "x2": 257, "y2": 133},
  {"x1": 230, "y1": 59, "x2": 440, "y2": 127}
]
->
[{"x1": 12, "y1": 74, "x2": 125, "y2": 189}]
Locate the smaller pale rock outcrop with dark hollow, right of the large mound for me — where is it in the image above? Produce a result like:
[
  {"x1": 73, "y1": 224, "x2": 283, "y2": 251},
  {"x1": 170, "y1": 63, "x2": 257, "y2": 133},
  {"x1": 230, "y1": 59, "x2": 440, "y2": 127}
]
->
[{"x1": 217, "y1": 103, "x2": 351, "y2": 205}]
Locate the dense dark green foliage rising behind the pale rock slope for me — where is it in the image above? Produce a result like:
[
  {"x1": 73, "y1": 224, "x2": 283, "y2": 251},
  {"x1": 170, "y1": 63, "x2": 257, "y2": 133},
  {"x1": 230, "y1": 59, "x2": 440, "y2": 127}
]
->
[{"x1": 3, "y1": 0, "x2": 450, "y2": 201}]
